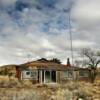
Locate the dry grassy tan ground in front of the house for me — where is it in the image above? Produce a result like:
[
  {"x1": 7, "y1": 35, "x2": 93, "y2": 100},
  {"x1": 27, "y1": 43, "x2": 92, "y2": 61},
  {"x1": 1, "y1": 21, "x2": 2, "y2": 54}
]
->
[{"x1": 0, "y1": 76, "x2": 100, "y2": 100}]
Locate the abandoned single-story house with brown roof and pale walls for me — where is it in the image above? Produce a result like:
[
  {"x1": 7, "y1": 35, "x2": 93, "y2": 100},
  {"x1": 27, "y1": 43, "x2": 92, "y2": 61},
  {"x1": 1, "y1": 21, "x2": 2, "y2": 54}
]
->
[{"x1": 16, "y1": 60, "x2": 91, "y2": 84}]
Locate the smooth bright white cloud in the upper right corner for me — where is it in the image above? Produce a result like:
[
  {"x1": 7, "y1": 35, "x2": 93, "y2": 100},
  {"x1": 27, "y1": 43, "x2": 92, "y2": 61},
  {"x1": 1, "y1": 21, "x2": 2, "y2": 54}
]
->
[{"x1": 72, "y1": 0, "x2": 100, "y2": 26}]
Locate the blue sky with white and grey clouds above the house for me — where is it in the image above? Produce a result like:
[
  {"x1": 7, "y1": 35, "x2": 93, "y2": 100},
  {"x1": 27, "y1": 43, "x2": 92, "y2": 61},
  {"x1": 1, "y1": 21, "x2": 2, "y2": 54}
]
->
[{"x1": 0, "y1": 0, "x2": 100, "y2": 65}]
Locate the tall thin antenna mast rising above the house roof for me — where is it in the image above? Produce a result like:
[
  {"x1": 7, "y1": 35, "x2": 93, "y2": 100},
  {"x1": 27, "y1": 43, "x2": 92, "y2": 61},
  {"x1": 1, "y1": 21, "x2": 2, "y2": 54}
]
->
[{"x1": 68, "y1": 10, "x2": 73, "y2": 65}]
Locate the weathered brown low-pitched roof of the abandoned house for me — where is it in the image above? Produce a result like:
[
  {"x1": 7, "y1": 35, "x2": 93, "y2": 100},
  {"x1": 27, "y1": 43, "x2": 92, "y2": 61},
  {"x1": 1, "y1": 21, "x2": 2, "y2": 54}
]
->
[{"x1": 21, "y1": 60, "x2": 90, "y2": 71}]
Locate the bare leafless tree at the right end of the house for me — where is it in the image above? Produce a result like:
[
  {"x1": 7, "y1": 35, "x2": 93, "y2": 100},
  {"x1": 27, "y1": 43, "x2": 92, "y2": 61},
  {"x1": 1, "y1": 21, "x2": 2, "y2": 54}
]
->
[{"x1": 82, "y1": 48, "x2": 100, "y2": 82}]
